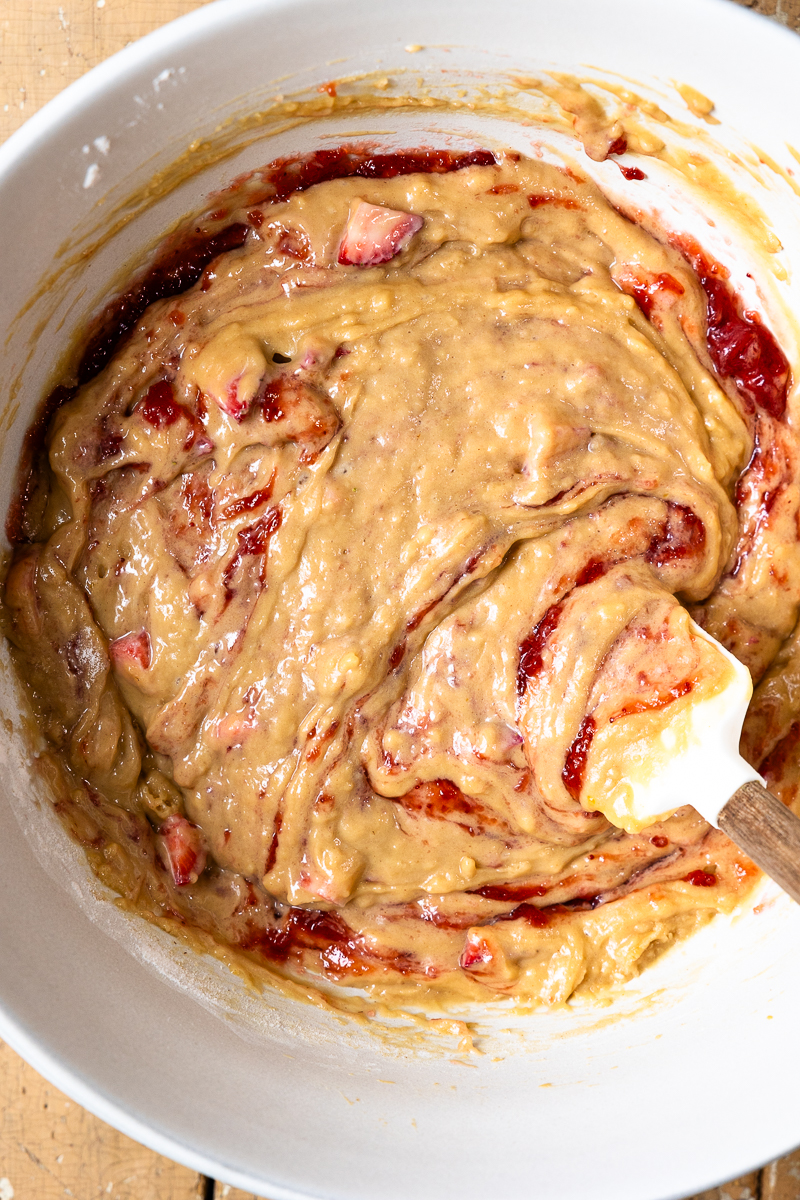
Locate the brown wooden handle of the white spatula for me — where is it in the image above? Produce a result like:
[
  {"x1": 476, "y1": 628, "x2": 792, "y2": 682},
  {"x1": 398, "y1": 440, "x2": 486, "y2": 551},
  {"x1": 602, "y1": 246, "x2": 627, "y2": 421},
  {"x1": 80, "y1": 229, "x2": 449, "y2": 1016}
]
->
[{"x1": 717, "y1": 780, "x2": 800, "y2": 904}]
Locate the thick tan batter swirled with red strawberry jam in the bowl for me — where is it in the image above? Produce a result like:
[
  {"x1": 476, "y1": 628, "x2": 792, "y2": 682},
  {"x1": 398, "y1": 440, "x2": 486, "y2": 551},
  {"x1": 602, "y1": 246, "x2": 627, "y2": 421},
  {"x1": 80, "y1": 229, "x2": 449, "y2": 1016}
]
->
[{"x1": 5, "y1": 149, "x2": 800, "y2": 1003}]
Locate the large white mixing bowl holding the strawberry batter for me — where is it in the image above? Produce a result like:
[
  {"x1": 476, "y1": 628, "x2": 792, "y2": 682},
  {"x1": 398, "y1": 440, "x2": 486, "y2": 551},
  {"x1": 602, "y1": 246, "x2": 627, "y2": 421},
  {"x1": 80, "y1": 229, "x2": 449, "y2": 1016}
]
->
[{"x1": 0, "y1": 0, "x2": 800, "y2": 1200}]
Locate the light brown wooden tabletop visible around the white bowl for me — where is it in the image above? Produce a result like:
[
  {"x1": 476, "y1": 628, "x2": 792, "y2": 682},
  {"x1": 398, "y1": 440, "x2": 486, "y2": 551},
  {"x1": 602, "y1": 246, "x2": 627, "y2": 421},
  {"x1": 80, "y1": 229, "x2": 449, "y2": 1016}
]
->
[{"x1": 0, "y1": 0, "x2": 800, "y2": 1200}]
